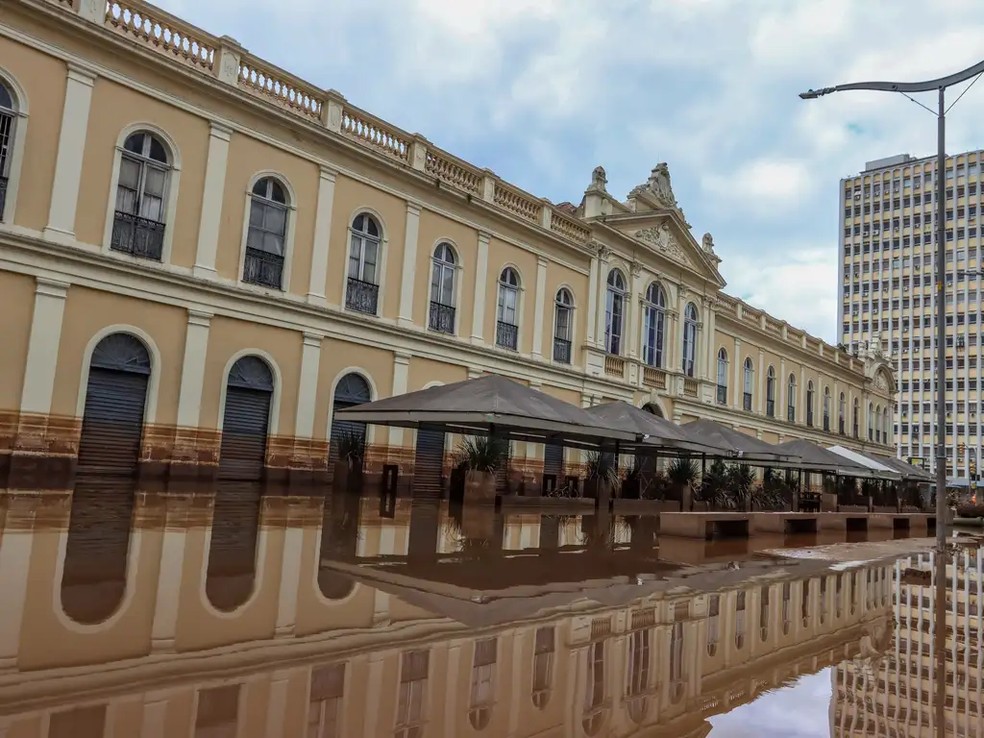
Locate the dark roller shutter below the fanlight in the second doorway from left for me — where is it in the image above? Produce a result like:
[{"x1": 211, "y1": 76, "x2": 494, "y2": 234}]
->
[{"x1": 219, "y1": 385, "x2": 272, "y2": 480}]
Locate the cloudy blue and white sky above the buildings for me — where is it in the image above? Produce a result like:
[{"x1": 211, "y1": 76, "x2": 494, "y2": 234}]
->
[{"x1": 157, "y1": 0, "x2": 984, "y2": 340}]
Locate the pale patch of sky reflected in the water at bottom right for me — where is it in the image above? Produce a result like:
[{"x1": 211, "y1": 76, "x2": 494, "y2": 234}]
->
[{"x1": 708, "y1": 669, "x2": 831, "y2": 738}]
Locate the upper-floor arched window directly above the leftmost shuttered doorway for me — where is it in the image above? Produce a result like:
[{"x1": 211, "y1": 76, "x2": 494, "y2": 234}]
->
[{"x1": 113, "y1": 131, "x2": 171, "y2": 261}]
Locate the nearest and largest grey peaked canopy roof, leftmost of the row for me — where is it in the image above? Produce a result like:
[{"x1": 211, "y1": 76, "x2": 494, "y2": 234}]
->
[{"x1": 335, "y1": 375, "x2": 639, "y2": 448}]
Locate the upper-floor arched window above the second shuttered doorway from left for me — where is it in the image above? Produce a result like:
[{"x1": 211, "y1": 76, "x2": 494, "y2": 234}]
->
[{"x1": 243, "y1": 177, "x2": 288, "y2": 290}]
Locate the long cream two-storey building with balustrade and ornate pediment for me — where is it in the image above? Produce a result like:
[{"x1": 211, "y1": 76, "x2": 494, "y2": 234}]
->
[{"x1": 0, "y1": 0, "x2": 894, "y2": 487}]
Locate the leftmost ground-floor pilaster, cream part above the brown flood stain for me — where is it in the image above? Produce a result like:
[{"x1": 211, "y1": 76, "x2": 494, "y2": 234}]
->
[{"x1": 21, "y1": 277, "x2": 69, "y2": 415}]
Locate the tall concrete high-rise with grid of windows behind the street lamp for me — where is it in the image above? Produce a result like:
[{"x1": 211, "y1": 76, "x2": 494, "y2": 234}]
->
[{"x1": 839, "y1": 151, "x2": 984, "y2": 485}]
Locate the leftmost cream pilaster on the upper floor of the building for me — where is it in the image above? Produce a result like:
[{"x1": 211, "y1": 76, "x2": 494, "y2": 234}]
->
[{"x1": 44, "y1": 62, "x2": 96, "y2": 241}]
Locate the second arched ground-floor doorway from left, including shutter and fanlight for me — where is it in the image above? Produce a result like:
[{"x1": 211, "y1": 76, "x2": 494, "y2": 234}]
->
[{"x1": 219, "y1": 356, "x2": 273, "y2": 480}]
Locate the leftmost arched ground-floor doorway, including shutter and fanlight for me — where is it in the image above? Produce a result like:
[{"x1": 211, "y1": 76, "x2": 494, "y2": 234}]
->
[{"x1": 78, "y1": 333, "x2": 151, "y2": 476}]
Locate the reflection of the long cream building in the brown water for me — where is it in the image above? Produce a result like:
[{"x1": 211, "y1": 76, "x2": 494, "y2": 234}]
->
[{"x1": 0, "y1": 486, "x2": 891, "y2": 738}]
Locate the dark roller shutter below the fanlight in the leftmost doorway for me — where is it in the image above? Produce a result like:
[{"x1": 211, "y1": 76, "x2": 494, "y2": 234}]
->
[{"x1": 78, "y1": 366, "x2": 148, "y2": 476}]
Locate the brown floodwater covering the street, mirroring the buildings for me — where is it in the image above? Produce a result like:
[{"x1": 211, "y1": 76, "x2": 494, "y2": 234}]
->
[{"x1": 0, "y1": 479, "x2": 984, "y2": 738}]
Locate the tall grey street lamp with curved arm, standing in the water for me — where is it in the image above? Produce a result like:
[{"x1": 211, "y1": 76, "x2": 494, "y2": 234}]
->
[{"x1": 800, "y1": 61, "x2": 984, "y2": 555}]
